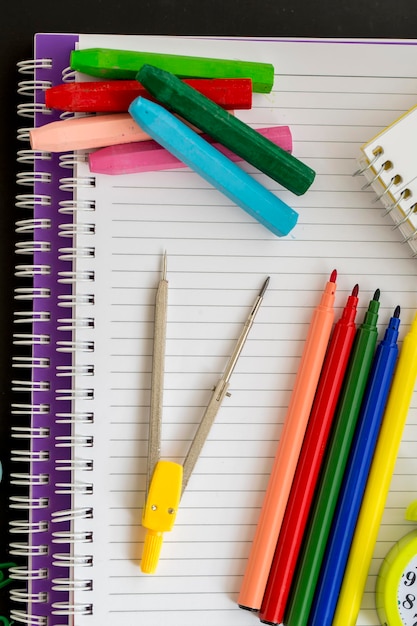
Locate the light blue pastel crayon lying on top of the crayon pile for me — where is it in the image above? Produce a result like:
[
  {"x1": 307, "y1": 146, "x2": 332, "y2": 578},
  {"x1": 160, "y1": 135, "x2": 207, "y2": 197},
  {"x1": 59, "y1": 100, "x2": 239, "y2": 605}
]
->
[{"x1": 129, "y1": 98, "x2": 298, "y2": 237}]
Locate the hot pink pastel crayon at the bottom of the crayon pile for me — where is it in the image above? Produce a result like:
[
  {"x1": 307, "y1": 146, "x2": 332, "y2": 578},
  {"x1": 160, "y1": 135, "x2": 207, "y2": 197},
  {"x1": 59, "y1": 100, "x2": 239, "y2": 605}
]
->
[{"x1": 88, "y1": 126, "x2": 292, "y2": 174}]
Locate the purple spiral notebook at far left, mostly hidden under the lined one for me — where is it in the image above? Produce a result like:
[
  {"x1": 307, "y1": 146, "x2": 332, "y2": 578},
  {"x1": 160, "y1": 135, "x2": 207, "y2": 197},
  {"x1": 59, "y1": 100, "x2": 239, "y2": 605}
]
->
[{"x1": 10, "y1": 31, "x2": 80, "y2": 624}]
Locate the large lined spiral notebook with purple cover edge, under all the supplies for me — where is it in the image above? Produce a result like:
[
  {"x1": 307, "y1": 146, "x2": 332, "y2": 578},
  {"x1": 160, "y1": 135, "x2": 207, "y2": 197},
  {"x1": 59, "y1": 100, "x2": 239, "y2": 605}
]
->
[{"x1": 11, "y1": 34, "x2": 417, "y2": 626}]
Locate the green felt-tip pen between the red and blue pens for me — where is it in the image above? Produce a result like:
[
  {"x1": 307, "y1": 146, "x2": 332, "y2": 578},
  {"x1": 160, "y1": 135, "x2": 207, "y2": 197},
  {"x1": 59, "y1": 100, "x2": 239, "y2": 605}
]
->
[{"x1": 284, "y1": 289, "x2": 380, "y2": 626}]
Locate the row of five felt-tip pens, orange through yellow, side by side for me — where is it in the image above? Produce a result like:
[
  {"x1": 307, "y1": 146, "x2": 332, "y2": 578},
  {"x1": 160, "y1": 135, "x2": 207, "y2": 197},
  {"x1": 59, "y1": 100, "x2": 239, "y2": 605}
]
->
[{"x1": 238, "y1": 271, "x2": 417, "y2": 626}]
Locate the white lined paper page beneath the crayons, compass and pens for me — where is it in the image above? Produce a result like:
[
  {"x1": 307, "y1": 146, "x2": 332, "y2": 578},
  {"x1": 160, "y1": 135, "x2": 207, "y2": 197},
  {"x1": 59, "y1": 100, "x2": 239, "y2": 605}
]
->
[{"x1": 74, "y1": 35, "x2": 417, "y2": 626}]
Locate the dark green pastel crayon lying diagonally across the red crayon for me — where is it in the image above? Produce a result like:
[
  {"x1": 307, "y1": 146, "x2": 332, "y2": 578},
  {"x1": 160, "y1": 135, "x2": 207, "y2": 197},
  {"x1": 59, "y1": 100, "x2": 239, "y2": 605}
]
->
[{"x1": 137, "y1": 65, "x2": 315, "y2": 196}]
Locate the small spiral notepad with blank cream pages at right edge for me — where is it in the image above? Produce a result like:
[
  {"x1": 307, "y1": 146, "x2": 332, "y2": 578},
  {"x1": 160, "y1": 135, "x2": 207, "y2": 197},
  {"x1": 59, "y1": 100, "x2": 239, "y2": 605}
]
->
[{"x1": 358, "y1": 106, "x2": 417, "y2": 256}]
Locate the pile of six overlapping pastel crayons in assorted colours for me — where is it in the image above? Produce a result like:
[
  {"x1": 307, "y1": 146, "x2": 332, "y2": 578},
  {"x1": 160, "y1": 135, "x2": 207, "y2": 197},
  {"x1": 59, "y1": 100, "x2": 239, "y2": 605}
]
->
[{"x1": 30, "y1": 49, "x2": 315, "y2": 236}]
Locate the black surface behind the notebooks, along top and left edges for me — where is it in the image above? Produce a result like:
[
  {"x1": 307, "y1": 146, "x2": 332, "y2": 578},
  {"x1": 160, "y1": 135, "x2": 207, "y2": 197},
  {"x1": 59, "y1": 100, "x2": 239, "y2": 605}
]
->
[{"x1": 0, "y1": 0, "x2": 417, "y2": 616}]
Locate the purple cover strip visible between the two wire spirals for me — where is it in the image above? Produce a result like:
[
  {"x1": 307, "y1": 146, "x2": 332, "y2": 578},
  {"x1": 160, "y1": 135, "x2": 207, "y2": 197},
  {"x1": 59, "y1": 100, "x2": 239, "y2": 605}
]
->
[{"x1": 28, "y1": 34, "x2": 78, "y2": 624}]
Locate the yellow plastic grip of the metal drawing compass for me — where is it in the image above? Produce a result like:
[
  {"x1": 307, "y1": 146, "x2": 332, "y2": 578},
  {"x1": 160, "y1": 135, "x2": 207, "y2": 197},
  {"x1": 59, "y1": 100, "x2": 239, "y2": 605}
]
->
[{"x1": 141, "y1": 461, "x2": 183, "y2": 574}]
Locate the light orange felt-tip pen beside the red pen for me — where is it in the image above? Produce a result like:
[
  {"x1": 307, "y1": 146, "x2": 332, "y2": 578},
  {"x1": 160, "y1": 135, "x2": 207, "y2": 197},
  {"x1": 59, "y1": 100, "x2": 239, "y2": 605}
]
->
[{"x1": 238, "y1": 270, "x2": 337, "y2": 611}]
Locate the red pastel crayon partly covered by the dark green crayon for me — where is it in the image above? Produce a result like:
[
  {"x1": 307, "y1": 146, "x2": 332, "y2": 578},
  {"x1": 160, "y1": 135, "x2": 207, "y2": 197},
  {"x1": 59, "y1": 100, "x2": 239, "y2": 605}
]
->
[{"x1": 45, "y1": 78, "x2": 252, "y2": 113}]
